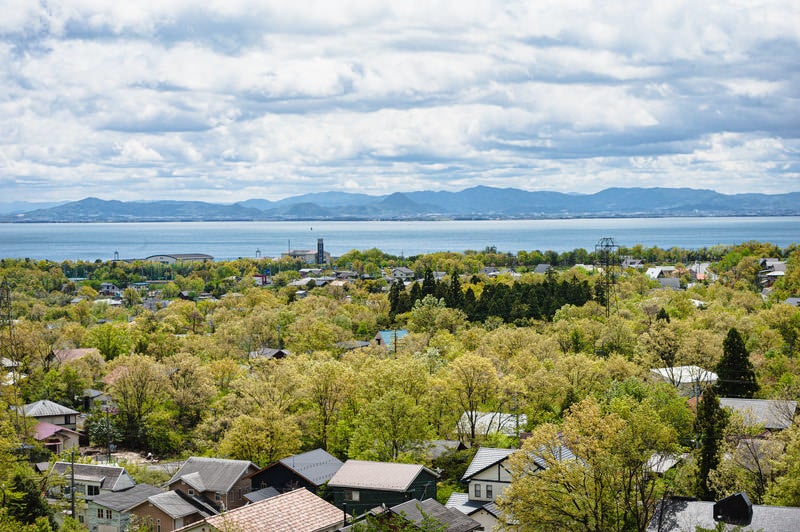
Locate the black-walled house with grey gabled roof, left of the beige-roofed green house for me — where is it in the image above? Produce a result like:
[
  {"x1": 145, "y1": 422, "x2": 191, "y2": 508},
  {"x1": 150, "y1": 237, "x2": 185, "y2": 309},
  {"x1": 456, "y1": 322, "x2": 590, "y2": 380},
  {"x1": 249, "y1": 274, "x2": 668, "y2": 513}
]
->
[{"x1": 250, "y1": 449, "x2": 342, "y2": 493}]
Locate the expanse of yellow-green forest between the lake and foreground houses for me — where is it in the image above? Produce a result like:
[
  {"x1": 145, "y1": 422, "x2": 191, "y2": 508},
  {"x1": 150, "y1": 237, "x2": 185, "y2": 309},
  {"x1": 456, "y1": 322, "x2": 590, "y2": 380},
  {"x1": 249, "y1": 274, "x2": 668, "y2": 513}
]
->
[{"x1": 0, "y1": 242, "x2": 800, "y2": 531}]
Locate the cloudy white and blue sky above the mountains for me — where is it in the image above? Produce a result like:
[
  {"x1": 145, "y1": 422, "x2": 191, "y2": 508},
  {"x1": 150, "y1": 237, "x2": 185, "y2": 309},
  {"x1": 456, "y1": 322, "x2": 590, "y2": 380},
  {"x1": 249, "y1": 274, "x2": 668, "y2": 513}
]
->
[{"x1": 0, "y1": 0, "x2": 800, "y2": 203}]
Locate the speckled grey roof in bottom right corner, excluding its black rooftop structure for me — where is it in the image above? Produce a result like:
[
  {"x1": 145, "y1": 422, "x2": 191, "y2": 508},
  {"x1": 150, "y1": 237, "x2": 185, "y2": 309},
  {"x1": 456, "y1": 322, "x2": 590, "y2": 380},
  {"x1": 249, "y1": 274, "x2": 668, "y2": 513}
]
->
[{"x1": 647, "y1": 499, "x2": 800, "y2": 532}]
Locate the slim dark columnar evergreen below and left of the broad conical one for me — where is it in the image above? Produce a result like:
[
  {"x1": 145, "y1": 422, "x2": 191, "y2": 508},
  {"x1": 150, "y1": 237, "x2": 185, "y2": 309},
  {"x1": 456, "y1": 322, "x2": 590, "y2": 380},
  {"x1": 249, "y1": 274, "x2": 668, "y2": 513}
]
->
[{"x1": 694, "y1": 386, "x2": 728, "y2": 501}]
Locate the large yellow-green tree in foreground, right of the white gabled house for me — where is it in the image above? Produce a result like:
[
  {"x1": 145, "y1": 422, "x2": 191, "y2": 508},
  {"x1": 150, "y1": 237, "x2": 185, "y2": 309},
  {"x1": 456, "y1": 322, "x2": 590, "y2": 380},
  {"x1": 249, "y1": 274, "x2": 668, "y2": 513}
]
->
[{"x1": 499, "y1": 397, "x2": 676, "y2": 532}]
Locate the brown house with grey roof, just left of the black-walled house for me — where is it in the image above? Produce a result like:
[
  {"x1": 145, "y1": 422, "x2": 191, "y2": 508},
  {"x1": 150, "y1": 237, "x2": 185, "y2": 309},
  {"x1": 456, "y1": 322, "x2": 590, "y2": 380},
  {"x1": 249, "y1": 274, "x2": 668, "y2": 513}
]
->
[{"x1": 167, "y1": 456, "x2": 258, "y2": 510}]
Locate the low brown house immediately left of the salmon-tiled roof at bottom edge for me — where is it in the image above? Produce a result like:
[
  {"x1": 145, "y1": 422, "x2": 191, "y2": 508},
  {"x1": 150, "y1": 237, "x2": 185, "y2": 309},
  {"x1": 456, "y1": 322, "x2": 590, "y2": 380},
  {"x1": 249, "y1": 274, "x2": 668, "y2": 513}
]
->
[{"x1": 128, "y1": 489, "x2": 219, "y2": 532}]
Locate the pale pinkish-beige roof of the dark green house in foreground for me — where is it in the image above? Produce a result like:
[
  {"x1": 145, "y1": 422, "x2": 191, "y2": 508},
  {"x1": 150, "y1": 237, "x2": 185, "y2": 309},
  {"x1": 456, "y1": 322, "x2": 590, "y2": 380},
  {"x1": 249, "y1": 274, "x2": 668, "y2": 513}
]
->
[{"x1": 328, "y1": 460, "x2": 439, "y2": 491}]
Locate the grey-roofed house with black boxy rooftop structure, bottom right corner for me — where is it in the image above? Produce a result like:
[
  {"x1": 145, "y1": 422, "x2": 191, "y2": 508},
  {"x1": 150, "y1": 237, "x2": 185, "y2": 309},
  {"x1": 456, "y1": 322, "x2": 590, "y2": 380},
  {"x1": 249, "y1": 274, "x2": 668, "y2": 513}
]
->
[{"x1": 647, "y1": 493, "x2": 800, "y2": 532}]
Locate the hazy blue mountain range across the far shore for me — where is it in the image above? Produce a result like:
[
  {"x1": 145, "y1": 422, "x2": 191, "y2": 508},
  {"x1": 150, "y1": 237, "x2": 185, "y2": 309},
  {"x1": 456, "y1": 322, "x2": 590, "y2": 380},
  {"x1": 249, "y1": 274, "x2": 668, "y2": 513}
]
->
[{"x1": 0, "y1": 186, "x2": 800, "y2": 222}]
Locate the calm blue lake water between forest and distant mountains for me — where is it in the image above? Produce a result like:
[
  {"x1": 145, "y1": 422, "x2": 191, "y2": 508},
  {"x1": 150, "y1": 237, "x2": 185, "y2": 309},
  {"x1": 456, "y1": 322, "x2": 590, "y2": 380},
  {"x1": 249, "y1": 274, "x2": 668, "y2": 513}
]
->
[{"x1": 0, "y1": 216, "x2": 800, "y2": 261}]
